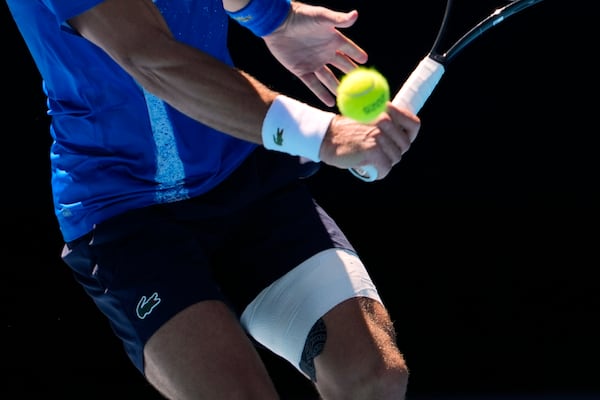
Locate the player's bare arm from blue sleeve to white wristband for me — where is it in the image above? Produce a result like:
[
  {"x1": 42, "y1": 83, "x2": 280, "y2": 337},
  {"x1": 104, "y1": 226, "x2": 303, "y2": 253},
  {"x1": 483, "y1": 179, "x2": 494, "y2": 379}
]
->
[{"x1": 69, "y1": 0, "x2": 276, "y2": 143}]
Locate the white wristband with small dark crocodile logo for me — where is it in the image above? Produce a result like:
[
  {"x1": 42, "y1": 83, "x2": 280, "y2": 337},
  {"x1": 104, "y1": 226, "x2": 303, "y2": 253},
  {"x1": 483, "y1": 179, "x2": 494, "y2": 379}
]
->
[{"x1": 262, "y1": 95, "x2": 335, "y2": 162}]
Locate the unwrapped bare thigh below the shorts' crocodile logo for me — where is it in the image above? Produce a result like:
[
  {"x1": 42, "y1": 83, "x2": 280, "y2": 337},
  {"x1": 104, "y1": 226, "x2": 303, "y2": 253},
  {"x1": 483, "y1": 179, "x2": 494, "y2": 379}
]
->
[{"x1": 144, "y1": 300, "x2": 278, "y2": 400}]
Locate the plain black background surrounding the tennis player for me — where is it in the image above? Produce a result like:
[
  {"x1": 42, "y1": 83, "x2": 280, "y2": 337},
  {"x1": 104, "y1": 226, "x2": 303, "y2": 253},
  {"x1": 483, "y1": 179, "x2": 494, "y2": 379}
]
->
[{"x1": 0, "y1": 0, "x2": 600, "y2": 399}]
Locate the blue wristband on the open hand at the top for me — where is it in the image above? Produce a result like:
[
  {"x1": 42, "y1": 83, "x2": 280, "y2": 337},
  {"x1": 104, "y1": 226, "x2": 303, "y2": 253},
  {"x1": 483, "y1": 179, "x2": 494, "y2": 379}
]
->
[{"x1": 227, "y1": 0, "x2": 291, "y2": 37}]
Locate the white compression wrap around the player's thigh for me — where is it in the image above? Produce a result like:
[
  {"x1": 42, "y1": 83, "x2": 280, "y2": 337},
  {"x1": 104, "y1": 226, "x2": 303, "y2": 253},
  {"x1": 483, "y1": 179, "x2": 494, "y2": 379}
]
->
[{"x1": 241, "y1": 249, "x2": 381, "y2": 375}]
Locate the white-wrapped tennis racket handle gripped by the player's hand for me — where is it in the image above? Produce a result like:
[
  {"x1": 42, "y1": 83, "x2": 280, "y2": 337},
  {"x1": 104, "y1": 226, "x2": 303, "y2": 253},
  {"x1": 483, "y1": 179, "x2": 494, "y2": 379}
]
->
[{"x1": 350, "y1": 56, "x2": 444, "y2": 182}]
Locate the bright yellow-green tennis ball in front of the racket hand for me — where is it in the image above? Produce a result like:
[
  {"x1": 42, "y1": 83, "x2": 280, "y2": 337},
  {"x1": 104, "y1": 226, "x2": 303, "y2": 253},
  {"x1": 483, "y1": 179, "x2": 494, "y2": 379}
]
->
[{"x1": 337, "y1": 67, "x2": 390, "y2": 123}]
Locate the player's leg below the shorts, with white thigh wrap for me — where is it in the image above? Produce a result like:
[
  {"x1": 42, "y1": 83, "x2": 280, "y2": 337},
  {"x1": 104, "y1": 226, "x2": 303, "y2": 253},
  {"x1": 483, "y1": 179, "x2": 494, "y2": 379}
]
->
[{"x1": 242, "y1": 249, "x2": 408, "y2": 400}]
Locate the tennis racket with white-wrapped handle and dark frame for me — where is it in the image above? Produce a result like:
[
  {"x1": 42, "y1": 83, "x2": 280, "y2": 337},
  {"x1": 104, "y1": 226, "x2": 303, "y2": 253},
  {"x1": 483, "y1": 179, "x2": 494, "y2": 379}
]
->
[{"x1": 350, "y1": 0, "x2": 542, "y2": 182}]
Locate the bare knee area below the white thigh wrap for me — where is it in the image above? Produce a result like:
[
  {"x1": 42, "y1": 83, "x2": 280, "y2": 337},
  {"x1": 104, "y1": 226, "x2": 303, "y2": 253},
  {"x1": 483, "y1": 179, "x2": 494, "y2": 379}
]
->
[{"x1": 315, "y1": 297, "x2": 408, "y2": 399}]
